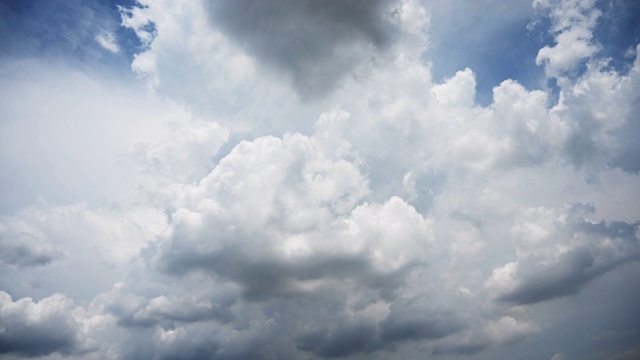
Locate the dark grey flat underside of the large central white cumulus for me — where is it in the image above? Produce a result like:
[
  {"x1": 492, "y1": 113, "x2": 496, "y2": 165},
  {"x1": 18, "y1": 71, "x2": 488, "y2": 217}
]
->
[{"x1": 158, "y1": 242, "x2": 417, "y2": 301}]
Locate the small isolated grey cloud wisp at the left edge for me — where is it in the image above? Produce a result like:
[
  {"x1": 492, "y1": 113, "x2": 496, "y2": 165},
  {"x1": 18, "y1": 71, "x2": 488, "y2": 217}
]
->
[{"x1": 0, "y1": 233, "x2": 63, "y2": 267}]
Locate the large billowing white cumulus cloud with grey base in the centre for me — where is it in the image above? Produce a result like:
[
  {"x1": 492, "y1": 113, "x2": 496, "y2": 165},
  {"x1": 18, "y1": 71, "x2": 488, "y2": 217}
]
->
[{"x1": 154, "y1": 126, "x2": 430, "y2": 299}]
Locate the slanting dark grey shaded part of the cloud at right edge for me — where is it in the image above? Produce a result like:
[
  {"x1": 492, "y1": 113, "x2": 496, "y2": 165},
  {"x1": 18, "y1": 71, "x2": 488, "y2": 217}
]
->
[{"x1": 498, "y1": 204, "x2": 640, "y2": 305}]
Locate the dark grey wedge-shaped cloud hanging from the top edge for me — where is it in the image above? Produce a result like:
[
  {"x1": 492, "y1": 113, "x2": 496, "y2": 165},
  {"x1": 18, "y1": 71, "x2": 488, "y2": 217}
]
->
[{"x1": 208, "y1": 0, "x2": 398, "y2": 98}]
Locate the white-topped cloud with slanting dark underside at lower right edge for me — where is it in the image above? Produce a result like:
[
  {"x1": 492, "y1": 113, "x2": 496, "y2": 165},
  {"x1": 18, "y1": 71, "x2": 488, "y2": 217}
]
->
[{"x1": 486, "y1": 204, "x2": 640, "y2": 305}]
